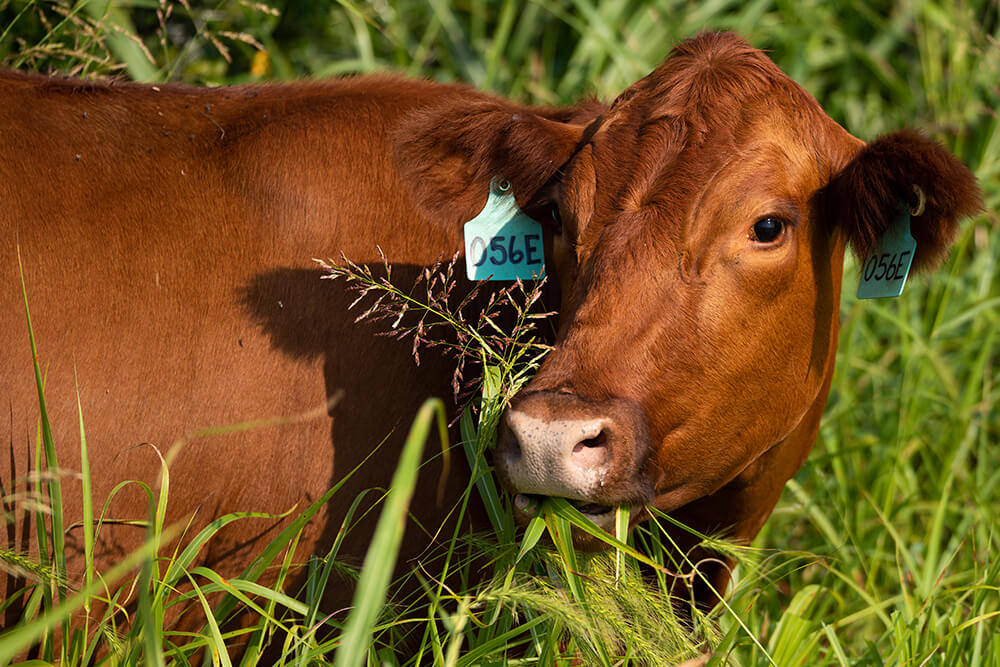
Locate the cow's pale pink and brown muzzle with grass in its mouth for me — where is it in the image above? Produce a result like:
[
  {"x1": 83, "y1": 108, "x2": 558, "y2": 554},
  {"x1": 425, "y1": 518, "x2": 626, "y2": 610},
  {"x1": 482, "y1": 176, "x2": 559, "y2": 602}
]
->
[{"x1": 495, "y1": 391, "x2": 654, "y2": 529}]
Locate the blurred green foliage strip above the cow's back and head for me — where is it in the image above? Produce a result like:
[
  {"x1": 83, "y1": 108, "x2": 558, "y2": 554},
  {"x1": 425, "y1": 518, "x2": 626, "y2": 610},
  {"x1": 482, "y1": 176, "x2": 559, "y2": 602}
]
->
[{"x1": 0, "y1": 0, "x2": 1000, "y2": 165}]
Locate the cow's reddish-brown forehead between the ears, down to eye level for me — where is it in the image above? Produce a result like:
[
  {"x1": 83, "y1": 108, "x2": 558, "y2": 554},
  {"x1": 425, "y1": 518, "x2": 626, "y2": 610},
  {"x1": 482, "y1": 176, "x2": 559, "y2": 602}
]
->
[{"x1": 578, "y1": 35, "x2": 862, "y2": 298}]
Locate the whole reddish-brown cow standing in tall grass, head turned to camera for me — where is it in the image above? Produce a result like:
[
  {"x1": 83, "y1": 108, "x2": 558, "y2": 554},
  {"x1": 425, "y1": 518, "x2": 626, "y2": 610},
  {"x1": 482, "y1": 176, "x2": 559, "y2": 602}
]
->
[{"x1": 0, "y1": 33, "x2": 981, "y2": 648}]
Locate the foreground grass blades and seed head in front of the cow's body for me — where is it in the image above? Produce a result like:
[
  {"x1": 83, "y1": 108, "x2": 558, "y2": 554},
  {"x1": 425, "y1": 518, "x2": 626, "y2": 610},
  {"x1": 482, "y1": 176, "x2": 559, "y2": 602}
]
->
[{"x1": 0, "y1": 264, "x2": 713, "y2": 666}]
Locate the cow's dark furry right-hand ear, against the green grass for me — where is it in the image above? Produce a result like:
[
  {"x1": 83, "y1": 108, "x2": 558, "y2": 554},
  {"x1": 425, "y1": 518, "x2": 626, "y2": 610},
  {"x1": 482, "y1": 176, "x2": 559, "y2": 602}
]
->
[{"x1": 821, "y1": 130, "x2": 983, "y2": 270}]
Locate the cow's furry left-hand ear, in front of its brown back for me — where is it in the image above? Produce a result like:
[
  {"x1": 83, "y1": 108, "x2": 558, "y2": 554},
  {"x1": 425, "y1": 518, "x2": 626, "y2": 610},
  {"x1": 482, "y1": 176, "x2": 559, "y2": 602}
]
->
[{"x1": 394, "y1": 101, "x2": 585, "y2": 222}]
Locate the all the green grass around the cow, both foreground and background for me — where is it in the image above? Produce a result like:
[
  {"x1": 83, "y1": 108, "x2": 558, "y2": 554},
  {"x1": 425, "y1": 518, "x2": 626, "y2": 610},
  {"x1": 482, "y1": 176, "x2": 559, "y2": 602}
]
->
[{"x1": 0, "y1": 0, "x2": 1000, "y2": 665}]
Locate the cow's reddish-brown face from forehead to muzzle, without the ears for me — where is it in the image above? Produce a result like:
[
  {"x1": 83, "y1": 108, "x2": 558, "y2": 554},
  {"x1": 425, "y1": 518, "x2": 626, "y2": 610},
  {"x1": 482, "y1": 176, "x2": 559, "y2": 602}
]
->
[{"x1": 496, "y1": 61, "x2": 860, "y2": 524}]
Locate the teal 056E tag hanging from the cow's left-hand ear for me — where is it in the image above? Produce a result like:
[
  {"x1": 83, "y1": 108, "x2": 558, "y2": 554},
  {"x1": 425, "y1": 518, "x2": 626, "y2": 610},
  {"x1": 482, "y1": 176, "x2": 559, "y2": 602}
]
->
[{"x1": 464, "y1": 181, "x2": 545, "y2": 280}]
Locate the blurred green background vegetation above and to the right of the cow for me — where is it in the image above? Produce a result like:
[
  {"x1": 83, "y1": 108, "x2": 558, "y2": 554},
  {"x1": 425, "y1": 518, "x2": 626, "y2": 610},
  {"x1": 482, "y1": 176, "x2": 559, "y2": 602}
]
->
[{"x1": 0, "y1": 0, "x2": 1000, "y2": 665}]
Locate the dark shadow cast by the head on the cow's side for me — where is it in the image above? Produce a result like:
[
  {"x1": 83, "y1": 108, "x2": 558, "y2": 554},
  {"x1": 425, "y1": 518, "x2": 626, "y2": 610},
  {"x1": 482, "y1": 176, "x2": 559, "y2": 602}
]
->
[{"x1": 239, "y1": 264, "x2": 496, "y2": 612}]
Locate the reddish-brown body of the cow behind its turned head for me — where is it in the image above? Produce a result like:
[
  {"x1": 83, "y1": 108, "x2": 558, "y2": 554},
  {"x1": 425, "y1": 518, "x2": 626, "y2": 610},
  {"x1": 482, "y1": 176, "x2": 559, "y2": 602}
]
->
[{"x1": 0, "y1": 73, "x2": 584, "y2": 624}]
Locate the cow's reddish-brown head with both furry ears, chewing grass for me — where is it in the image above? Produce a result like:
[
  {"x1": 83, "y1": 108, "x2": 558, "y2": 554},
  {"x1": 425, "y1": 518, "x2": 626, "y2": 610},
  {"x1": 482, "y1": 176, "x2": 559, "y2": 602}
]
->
[{"x1": 399, "y1": 34, "x2": 981, "y2": 538}]
